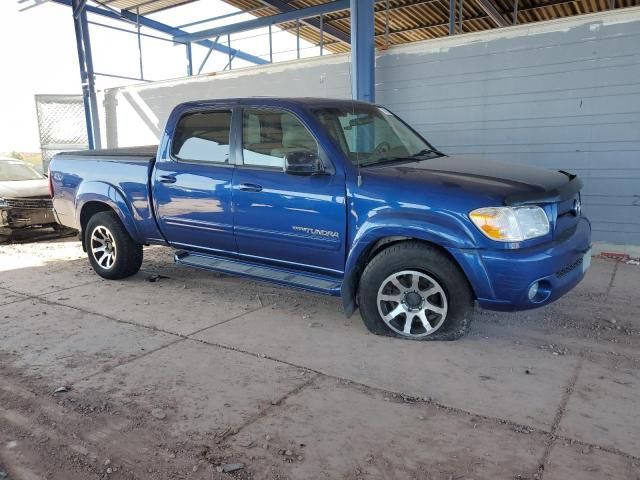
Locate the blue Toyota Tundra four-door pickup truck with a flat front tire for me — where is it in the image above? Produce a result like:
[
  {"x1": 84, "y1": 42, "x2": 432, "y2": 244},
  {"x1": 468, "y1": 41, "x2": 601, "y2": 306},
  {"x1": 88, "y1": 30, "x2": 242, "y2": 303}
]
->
[{"x1": 49, "y1": 98, "x2": 591, "y2": 340}]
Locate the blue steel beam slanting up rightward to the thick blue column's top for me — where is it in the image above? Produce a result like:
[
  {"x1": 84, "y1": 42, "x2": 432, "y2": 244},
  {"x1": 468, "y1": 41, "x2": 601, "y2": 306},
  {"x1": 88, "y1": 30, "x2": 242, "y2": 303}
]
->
[{"x1": 174, "y1": 0, "x2": 348, "y2": 42}]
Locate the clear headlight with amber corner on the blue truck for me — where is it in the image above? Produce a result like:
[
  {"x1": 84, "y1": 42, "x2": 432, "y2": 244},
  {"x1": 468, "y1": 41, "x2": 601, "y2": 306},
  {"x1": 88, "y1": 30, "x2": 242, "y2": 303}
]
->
[{"x1": 469, "y1": 207, "x2": 549, "y2": 242}]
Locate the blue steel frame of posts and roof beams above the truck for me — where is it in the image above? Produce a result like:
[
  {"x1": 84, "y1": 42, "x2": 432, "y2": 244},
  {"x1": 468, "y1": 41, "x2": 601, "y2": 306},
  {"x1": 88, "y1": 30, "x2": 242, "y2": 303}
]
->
[{"x1": 51, "y1": 0, "x2": 375, "y2": 149}]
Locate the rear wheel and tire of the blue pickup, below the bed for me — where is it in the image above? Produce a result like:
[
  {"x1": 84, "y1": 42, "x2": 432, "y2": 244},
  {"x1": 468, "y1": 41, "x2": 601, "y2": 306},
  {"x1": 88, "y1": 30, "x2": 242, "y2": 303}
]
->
[{"x1": 84, "y1": 212, "x2": 142, "y2": 280}]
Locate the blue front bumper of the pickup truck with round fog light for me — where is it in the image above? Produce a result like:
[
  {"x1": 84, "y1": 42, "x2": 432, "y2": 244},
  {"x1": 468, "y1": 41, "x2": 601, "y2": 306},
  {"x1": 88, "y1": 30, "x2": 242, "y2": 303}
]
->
[{"x1": 451, "y1": 217, "x2": 591, "y2": 311}]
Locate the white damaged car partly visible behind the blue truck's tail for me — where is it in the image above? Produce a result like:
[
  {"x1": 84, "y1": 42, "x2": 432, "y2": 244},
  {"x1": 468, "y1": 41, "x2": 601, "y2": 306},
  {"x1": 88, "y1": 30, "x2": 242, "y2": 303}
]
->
[{"x1": 0, "y1": 157, "x2": 59, "y2": 242}]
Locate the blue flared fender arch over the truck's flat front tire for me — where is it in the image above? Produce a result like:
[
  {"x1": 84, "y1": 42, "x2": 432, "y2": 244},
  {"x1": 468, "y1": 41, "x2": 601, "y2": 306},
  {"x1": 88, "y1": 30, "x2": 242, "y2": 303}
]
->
[{"x1": 341, "y1": 211, "x2": 477, "y2": 316}]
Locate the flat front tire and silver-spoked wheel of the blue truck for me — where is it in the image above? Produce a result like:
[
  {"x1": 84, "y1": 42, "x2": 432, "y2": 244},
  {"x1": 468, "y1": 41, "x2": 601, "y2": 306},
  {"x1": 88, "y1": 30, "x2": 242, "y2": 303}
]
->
[{"x1": 358, "y1": 241, "x2": 474, "y2": 340}]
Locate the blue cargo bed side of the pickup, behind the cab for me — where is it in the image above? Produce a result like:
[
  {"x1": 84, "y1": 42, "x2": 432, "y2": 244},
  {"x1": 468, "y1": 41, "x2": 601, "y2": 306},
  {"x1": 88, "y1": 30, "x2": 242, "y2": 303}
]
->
[{"x1": 49, "y1": 146, "x2": 164, "y2": 243}]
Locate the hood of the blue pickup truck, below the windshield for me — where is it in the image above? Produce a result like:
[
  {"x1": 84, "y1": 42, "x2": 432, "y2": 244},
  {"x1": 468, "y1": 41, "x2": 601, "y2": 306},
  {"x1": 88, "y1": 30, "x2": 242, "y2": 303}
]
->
[{"x1": 362, "y1": 156, "x2": 569, "y2": 200}]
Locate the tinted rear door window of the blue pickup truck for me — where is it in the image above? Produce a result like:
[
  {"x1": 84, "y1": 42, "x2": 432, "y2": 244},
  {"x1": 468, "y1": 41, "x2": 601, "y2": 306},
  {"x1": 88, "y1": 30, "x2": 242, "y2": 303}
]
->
[{"x1": 171, "y1": 110, "x2": 231, "y2": 163}]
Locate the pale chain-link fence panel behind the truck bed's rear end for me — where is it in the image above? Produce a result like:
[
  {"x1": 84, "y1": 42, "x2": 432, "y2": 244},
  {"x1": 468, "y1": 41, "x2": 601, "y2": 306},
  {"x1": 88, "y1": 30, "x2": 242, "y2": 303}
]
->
[{"x1": 36, "y1": 95, "x2": 88, "y2": 172}]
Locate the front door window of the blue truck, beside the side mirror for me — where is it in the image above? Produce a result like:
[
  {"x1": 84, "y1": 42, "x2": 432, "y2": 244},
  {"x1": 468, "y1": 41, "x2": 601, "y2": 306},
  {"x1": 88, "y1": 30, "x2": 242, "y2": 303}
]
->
[{"x1": 242, "y1": 108, "x2": 318, "y2": 170}]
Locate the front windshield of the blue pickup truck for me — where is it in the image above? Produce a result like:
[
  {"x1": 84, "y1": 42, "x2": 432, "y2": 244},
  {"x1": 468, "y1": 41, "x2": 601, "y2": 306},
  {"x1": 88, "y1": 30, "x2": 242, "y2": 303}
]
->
[{"x1": 313, "y1": 105, "x2": 444, "y2": 167}]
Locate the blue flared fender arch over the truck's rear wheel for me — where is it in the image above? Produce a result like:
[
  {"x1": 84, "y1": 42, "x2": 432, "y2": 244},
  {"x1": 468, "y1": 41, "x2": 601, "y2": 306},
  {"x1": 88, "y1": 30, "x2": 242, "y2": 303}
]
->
[{"x1": 75, "y1": 181, "x2": 142, "y2": 243}]
